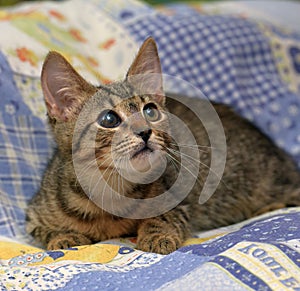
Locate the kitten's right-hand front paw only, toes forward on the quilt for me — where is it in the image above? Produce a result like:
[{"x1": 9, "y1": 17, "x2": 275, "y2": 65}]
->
[{"x1": 137, "y1": 234, "x2": 181, "y2": 255}]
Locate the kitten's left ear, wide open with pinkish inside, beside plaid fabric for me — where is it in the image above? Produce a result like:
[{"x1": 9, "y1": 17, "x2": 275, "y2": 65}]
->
[{"x1": 41, "y1": 52, "x2": 96, "y2": 121}]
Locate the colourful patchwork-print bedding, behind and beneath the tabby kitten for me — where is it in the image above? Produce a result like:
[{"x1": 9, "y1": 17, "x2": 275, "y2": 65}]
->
[{"x1": 0, "y1": 0, "x2": 300, "y2": 290}]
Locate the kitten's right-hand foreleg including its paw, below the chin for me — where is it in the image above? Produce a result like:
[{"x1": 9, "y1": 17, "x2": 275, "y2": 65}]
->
[{"x1": 137, "y1": 207, "x2": 190, "y2": 255}]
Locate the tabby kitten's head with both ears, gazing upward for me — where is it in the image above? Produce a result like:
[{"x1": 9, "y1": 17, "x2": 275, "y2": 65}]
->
[{"x1": 41, "y1": 38, "x2": 170, "y2": 177}]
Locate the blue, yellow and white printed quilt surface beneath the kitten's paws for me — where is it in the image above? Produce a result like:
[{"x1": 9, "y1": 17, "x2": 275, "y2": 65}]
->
[{"x1": 0, "y1": 208, "x2": 300, "y2": 291}]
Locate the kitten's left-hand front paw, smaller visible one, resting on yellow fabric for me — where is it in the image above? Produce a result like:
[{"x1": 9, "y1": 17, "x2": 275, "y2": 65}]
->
[{"x1": 47, "y1": 233, "x2": 91, "y2": 250}]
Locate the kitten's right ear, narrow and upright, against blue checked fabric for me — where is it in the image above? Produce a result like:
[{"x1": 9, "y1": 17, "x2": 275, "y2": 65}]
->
[{"x1": 127, "y1": 37, "x2": 164, "y2": 103}]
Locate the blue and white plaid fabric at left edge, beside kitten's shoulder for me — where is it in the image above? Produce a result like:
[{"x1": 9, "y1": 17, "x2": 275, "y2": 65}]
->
[{"x1": 0, "y1": 52, "x2": 51, "y2": 240}]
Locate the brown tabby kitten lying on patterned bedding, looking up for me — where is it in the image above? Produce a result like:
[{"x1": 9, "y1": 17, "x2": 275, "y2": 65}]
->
[{"x1": 27, "y1": 38, "x2": 300, "y2": 254}]
